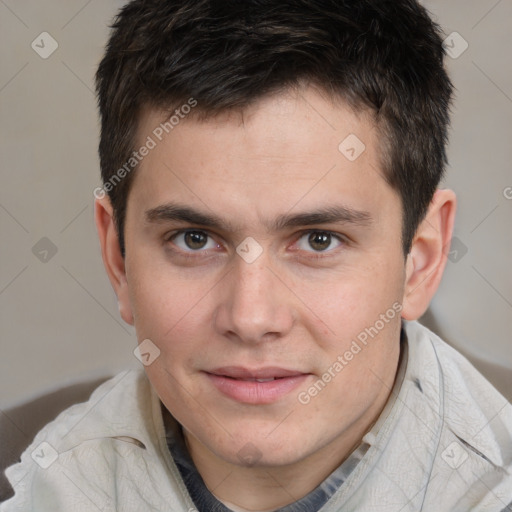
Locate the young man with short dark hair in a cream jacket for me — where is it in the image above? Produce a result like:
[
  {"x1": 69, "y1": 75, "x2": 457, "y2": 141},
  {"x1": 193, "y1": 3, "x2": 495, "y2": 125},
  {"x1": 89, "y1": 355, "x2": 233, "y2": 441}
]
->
[{"x1": 1, "y1": 0, "x2": 512, "y2": 512}]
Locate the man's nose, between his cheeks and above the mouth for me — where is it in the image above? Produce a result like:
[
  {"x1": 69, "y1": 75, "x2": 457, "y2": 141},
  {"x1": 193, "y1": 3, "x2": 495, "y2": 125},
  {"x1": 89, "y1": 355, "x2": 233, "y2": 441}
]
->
[{"x1": 214, "y1": 256, "x2": 295, "y2": 344}]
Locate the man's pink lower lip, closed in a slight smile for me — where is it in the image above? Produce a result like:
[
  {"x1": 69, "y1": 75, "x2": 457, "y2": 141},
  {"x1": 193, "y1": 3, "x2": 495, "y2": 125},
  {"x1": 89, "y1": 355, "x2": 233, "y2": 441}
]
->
[{"x1": 206, "y1": 373, "x2": 309, "y2": 405}]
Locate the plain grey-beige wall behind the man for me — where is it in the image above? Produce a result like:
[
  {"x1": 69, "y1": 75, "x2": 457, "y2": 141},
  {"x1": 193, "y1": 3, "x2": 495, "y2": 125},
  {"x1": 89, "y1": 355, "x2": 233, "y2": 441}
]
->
[{"x1": 0, "y1": 0, "x2": 512, "y2": 408}]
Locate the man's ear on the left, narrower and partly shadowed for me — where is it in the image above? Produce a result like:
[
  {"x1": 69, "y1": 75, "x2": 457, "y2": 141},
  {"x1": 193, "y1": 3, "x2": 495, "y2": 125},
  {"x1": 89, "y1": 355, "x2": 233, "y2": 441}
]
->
[{"x1": 94, "y1": 195, "x2": 133, "y2": 325}]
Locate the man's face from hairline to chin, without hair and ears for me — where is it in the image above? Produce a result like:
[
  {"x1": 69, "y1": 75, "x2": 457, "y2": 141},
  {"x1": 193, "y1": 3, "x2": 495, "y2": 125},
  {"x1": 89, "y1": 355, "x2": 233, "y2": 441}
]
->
[{"x1": 121, "y1": 88, "x2": 405, "y2": 466}]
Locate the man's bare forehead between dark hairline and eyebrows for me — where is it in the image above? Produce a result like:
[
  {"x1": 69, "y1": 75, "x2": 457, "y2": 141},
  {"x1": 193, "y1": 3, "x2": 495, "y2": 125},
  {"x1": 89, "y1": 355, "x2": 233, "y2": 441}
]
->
[{"x1": 127, "y1": 87, "x2": 398, "y2": 226}]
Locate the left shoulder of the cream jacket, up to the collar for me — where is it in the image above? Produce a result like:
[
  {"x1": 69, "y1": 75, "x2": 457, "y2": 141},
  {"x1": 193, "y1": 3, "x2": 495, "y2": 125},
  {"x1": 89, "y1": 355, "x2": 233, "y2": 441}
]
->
[{"x1": 0, "y1": 371, "x2": 188, "y2": 512}]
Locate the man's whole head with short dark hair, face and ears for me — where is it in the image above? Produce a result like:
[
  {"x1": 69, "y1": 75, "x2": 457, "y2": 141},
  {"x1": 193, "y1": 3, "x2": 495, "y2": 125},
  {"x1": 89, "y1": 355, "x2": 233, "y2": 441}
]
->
[{"x1": 96, "y1": 0, "x2": 454, "y2": 480}]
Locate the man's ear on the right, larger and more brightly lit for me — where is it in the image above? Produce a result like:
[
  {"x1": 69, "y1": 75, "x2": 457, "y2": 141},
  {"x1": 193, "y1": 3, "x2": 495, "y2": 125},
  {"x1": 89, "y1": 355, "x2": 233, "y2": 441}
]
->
[{"x1": 402, "y1": 190, "x2": 457, "y2": 320}]
